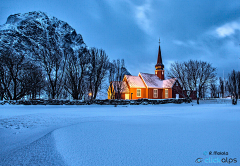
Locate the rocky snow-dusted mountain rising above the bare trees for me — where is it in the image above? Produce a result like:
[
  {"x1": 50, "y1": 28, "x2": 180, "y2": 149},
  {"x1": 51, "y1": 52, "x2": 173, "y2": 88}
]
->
[{"x1": 0, "y1": 11, "x2": 86, "y2": 53}]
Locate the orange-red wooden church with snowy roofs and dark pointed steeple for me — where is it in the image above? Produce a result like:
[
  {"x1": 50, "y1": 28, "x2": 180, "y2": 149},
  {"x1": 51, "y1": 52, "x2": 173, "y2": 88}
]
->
[{"x1": 108, "y1": 42, "x2": 181, "y2": 100}]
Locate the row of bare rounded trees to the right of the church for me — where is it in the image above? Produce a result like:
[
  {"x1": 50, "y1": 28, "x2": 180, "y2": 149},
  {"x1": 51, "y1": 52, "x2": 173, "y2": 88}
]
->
[{"x1": 168, "y1": 60, "x2": 240, "y2": 104}]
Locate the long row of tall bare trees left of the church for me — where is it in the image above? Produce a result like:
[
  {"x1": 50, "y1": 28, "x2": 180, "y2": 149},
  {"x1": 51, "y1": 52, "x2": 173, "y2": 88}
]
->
[{"x1": 0, "y1": 45, "x2": 124, "y2": 100}]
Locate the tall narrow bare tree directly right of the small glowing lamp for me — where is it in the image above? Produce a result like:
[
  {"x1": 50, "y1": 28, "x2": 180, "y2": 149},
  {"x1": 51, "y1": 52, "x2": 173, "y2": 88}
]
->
[{"x1": 88, "y1": 48, "x2": 109, "y2": 99}]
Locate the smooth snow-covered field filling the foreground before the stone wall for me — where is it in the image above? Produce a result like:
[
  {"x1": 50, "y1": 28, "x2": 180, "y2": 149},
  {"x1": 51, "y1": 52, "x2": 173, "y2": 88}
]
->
[{"x1": 0, "y1": 103, "x2": 240, "y2": 166}]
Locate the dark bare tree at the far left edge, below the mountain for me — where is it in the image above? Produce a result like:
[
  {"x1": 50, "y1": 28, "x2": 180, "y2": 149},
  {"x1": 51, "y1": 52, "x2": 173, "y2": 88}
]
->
[{"x1": 0, "y1": 49, "x2": 34, "y2": 100}]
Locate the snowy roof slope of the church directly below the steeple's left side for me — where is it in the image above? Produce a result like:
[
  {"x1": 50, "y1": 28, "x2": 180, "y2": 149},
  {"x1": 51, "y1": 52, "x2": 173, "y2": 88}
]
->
[{"x1": 139, "y1": 73, "x2": 163, "y2": 88}]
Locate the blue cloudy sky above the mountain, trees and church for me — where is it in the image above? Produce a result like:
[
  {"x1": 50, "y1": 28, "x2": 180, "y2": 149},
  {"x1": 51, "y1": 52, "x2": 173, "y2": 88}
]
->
[{"x1": 0, "y1": 0, "x2": 240, "y2": 76}]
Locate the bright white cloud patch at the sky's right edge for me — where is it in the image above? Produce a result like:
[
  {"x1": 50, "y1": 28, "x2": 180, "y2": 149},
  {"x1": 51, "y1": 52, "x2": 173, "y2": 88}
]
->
[{"x1": 216, "y1": 21, "x2": 240, "y2": 37}]
